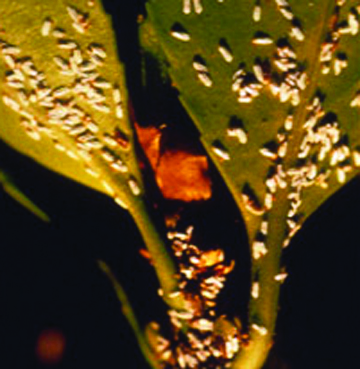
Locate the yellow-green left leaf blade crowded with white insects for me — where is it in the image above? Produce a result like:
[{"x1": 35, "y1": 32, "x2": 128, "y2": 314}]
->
[{"x1": 0, "y1": 0, "x2": 142, "y2": 208}]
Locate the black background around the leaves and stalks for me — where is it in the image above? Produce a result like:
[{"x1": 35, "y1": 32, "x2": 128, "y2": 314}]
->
[{"x1": 0, "y1": 0, "x2": 360, "y2": 369}]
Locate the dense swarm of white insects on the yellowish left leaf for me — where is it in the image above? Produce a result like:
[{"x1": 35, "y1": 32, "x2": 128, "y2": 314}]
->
[{"x1": 0, "y1": 2, "x2": 141, "y2": 207}]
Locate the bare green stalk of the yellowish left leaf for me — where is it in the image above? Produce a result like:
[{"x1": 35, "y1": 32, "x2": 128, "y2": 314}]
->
[{"x1": 130, "y1": 201, "x2": 186, "y2": 310}]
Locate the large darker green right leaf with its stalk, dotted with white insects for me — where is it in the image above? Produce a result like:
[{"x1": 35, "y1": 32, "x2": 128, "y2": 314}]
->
[{"x1": 141, "y1": 0, "x2": 360, "y2": 369}]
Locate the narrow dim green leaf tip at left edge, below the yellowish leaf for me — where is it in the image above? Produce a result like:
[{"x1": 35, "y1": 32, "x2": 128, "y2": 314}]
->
[{"x1": 0, "y1": 169, "x2": 50, "y2": 222}]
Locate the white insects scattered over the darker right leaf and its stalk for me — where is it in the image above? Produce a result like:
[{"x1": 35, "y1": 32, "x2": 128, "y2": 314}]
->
[{"x1": 170, "y1": 0, "x2": 360, "y2": 348}]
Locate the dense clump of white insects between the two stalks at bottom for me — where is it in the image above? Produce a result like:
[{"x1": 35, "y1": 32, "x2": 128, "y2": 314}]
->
[{"x1": 154, "y1": 227, "x2": 245, "y2": 369}]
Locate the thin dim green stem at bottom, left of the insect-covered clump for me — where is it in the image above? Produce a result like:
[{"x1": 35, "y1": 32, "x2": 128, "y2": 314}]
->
[{"x1": 98, "y1": 260, "x2": 160, "y2": 369}]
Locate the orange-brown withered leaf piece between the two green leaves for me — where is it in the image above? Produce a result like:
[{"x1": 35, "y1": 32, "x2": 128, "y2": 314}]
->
[{"x1": 136, "y1": 125, "x2": 211, "y2": 202}]
